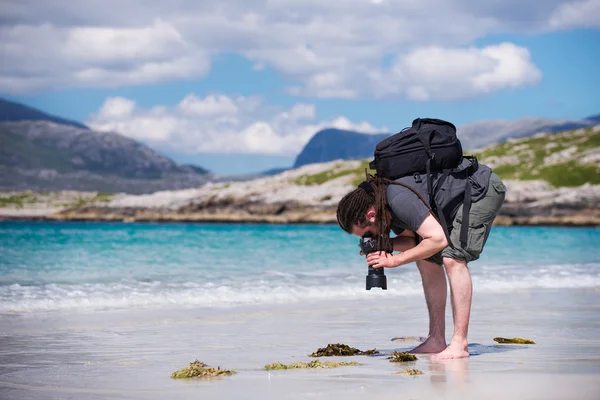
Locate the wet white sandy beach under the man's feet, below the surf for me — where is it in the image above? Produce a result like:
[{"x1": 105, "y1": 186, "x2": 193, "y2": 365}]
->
[{"x1": 0, "y1": 289, "x2": 600, "y2": 400}]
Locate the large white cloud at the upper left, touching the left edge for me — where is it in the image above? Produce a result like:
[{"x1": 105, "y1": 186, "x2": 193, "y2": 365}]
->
[{"x1": 0, "y1": 20, "x2": 210, "y2": 92}]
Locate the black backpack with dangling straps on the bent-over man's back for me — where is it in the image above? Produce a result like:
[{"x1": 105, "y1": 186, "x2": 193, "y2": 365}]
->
[{"x1": 369, "y1": 118, "x2": 478, "y2": 248}]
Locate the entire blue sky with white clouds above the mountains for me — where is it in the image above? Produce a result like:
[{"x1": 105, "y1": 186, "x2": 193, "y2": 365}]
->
[{"x1": 0, "y1": 0, "x2": 600, "y2": 174}]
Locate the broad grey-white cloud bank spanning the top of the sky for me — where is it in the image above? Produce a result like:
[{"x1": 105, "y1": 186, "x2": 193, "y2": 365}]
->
[{"x1": 0, "y1": 0, "x2": 600, "y2": 100}]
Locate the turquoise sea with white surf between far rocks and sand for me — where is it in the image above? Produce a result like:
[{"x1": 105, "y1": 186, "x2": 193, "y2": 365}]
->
[{"x1": 0, "y1": 222, "x2": 600, "y2": 313}]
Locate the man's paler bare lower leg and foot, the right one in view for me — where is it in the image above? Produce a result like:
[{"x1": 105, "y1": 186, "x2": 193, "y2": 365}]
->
[{"x1": 433, "y1": 257, "x2": 473, "y2": 360}]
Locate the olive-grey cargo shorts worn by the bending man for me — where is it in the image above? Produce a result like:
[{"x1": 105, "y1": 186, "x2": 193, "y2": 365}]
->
[{"x1": 426, "y1": 173, "x2": 506, "y2": 265}]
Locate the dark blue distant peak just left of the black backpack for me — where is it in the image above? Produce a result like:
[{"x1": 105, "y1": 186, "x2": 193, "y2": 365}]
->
[{"x1": 294, "y1": 129, "x2": 389, "y2": 168}]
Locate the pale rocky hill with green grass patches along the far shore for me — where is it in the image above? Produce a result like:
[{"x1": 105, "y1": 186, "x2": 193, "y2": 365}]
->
[{"x1": 0, "y1": 125, "x2": 600, "y2": 226}]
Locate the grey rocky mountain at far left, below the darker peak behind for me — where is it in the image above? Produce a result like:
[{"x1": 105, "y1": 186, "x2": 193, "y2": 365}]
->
[{"x1": 0, "y1": 121, "x2": 209, "y2": 193}]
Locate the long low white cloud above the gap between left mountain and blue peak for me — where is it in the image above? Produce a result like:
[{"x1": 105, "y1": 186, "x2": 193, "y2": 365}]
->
[{"x1": 86, "y1": 94, "x2": 388, "y2": 155}]
